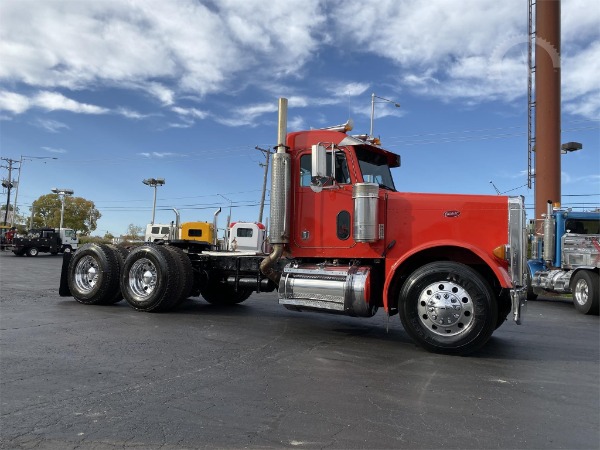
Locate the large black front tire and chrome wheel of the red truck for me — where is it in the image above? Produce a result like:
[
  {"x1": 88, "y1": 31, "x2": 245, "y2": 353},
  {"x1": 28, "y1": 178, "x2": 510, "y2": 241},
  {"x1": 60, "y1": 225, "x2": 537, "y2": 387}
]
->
[{"x1": 398, "y1": 261, "x2": 498, "y2": 355}]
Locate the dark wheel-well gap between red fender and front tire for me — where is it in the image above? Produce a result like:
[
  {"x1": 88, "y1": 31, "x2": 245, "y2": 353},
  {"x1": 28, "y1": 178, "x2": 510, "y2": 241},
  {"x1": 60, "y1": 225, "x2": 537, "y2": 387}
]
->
[{"x1": 388, "y1": 246, "x2": 507, "y2": 315}]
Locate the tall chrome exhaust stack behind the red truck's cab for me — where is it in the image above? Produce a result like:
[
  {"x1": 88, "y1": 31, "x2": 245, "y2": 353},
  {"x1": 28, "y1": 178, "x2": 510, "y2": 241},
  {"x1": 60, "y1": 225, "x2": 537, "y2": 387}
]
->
[{"x1": 260, "y1": 98, "x2": 291, "y2": 283}]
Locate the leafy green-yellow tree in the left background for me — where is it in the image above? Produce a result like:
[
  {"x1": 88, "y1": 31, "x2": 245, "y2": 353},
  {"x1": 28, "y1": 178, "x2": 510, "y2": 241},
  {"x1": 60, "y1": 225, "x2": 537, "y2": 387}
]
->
[{"x1": 32, "y1": 194, "x2": 102, "y2": 235}]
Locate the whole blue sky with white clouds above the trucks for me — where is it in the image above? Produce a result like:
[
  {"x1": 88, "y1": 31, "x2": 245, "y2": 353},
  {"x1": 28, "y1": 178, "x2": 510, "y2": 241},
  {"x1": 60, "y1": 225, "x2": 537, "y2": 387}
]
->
[{"x1": 0, "y1": 0, "x2": 600, "y2": 235}]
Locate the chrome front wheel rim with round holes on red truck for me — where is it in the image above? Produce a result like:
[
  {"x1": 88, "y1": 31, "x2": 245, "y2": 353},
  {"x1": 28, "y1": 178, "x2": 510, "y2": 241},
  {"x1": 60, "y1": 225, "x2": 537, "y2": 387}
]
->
[{"x1": 417, "y1": 281, "x2": 474, "y2": 336}]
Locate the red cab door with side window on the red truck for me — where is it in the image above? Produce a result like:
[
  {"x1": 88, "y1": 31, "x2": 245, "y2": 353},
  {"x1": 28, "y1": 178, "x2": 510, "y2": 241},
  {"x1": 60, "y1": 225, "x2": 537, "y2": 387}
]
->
[{"x1": 292, "y1": 149, "x2": 357, "y2": 254}]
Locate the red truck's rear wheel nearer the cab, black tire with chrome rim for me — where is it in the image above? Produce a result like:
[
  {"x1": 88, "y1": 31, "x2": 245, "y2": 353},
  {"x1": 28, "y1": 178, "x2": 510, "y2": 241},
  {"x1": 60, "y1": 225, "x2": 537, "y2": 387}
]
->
[{"x1": 121, "y1": 244, "x2": 181, "y2": 312}]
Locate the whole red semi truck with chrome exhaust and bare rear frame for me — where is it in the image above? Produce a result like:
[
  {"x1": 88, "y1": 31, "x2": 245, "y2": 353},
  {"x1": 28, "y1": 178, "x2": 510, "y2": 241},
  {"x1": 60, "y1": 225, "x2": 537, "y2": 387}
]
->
[{"x1": 60, "y1": 99, "x2": 526, "y2": 354}]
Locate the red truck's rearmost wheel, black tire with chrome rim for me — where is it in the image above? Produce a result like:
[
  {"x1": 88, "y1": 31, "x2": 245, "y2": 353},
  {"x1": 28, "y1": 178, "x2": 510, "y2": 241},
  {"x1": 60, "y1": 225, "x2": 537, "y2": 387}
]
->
[{"x1": 67, "y1": 243, "x2": 119, "y2": 305}]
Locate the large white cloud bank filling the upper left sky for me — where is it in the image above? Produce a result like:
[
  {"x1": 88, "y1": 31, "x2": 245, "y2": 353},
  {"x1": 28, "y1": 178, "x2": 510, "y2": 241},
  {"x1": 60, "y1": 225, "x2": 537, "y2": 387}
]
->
[{"x1": 0, "y1": 0, "x2": 324, "y2": 105}]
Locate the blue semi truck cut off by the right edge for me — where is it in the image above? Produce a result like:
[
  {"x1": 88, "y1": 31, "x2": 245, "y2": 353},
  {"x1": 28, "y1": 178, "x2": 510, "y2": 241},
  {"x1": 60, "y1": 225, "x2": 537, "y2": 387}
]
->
[{"x1": 527, "y1": 201, "x2": 600, "y2": 314}]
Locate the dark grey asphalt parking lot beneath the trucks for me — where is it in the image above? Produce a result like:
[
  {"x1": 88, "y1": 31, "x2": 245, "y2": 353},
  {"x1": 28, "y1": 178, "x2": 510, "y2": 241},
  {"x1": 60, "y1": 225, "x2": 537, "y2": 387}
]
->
[{"x1": 0, "y1": 252, "x2": 600, "y2": 449}]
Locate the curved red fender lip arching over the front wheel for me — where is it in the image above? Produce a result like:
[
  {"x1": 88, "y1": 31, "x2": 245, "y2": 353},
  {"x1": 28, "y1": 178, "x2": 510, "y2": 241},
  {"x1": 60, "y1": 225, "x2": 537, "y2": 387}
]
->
[{"x1": 383, "y1": 240, "x2": 512, "y2": 312}]
